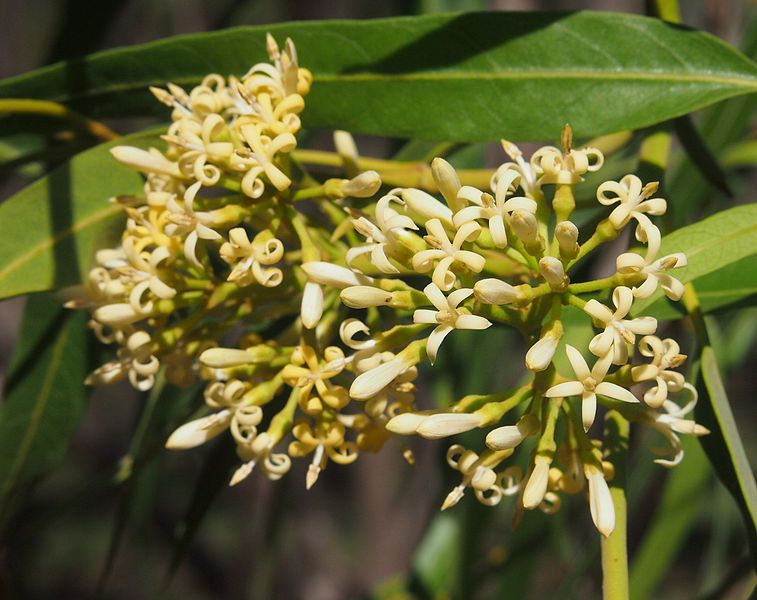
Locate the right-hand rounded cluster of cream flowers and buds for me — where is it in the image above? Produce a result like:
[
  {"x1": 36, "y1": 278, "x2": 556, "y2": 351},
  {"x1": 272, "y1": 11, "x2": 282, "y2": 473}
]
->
[{"x1": 332, "y1": 129, "x2": 707, "y2": 535}]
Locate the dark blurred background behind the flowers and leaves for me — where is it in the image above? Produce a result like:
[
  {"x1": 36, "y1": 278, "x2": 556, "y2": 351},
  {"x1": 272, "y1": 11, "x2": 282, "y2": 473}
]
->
[{"x1": 0, "y1": 0, "x2": 757, "y2": 600}]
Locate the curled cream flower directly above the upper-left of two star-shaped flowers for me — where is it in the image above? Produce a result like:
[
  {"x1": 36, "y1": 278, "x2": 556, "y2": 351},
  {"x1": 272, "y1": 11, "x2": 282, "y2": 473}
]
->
[{"x1": 413, "y1": 219, "x2": 486, "y2": 291}]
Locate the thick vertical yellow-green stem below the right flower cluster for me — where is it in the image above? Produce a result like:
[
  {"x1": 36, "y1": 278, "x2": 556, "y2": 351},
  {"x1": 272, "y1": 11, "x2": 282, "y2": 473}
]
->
[{"x1": 601, "y1": 411, "x2": 630, "y2": 600}]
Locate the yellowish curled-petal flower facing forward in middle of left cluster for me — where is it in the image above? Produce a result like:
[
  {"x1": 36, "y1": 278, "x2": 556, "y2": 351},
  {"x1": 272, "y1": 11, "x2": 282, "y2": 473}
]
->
[{"x1": 220, "y1": 227, "x2": 284, "y2": 287}]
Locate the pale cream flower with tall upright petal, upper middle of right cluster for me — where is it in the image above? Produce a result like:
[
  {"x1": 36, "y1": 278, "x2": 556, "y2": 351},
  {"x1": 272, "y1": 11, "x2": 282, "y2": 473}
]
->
[{"x1": 453, "y1": 170, "x2": 536, "y2": 248}]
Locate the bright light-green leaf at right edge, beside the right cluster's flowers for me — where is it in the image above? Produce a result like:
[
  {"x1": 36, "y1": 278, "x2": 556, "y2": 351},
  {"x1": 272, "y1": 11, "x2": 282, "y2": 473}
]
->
[{"x1": 634, "y1": 204, "x2": 757, "y2": 314}]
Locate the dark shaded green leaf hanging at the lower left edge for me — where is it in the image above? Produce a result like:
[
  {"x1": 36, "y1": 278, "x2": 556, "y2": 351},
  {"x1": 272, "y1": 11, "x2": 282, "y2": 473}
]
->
[{"x1": 0, "y1": 296, "x2": 90, "y2": 515}]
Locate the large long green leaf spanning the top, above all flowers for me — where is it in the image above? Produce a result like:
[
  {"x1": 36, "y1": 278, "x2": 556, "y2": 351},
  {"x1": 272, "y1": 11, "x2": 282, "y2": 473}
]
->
[{"x1": 0, "y1": 11, "x2": 757, "y2": 141}]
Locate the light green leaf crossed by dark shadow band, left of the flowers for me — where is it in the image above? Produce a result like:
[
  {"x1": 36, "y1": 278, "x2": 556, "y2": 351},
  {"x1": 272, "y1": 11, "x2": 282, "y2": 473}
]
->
[{"x1": 0, "y1": 133, "x2": 159, "y2": 298}]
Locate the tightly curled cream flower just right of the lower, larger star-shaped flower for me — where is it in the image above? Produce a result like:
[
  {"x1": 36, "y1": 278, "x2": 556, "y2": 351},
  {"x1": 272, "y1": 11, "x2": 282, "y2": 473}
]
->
[{"x1": 631, "y1": 335, "x2": 686, "y2": 408}]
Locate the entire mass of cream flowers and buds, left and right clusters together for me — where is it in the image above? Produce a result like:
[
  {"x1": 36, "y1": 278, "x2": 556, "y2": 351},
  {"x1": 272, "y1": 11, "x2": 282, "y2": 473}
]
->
[{"x1": 74, "y1": 36, "x2": 706, "y2": 535}]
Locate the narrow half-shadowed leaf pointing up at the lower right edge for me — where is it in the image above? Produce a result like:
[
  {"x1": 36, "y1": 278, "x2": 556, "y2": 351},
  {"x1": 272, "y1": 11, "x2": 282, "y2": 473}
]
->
[{"x1": 697, "y1": 346, "x2": 757, "y2": 565}]
